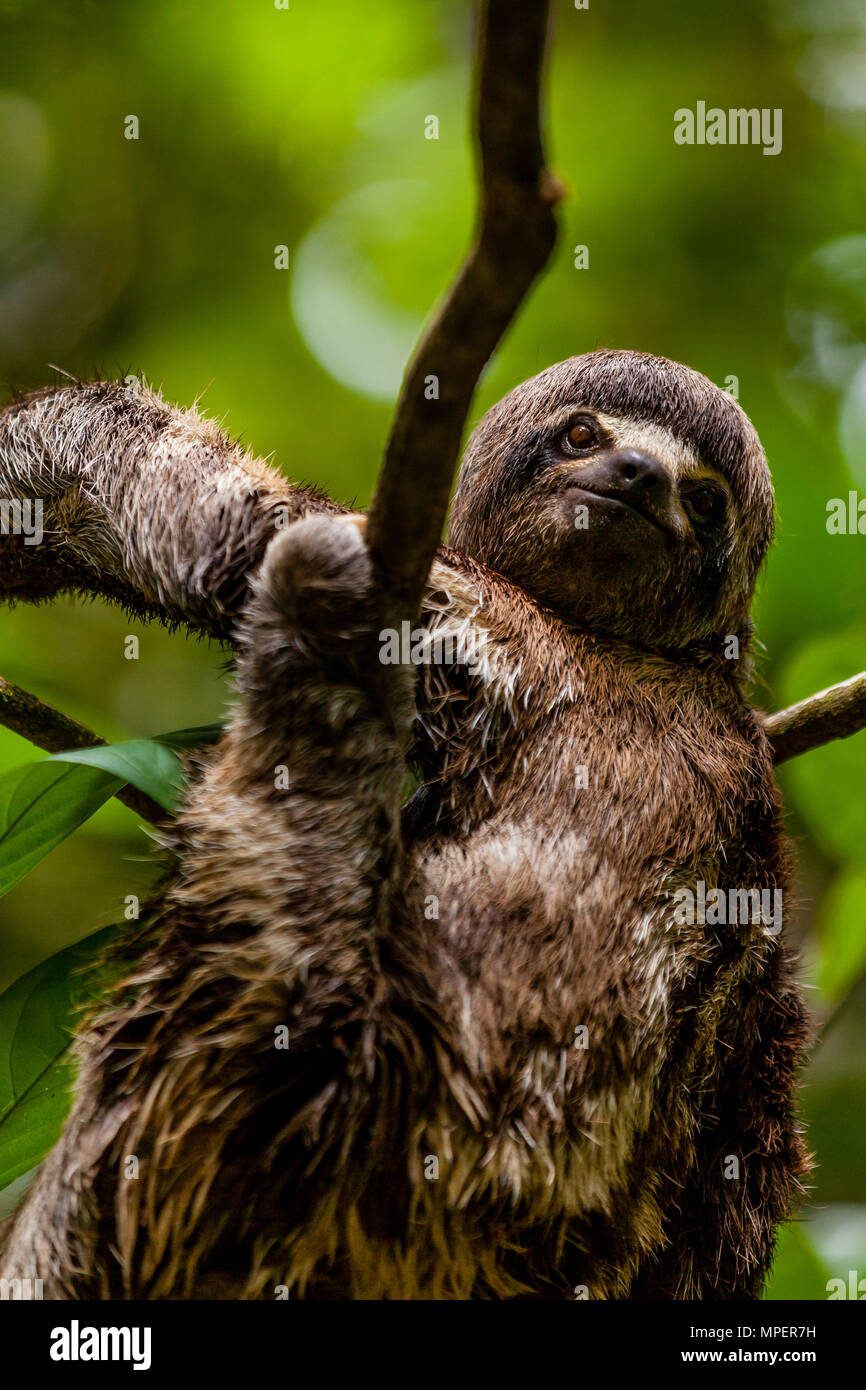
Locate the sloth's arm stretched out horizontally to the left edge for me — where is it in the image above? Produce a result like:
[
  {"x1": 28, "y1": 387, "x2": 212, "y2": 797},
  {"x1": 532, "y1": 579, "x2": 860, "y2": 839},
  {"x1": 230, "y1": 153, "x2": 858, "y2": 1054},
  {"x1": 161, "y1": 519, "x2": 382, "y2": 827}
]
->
[{"x1": 0, "y1": 378, "x2": 343, "y2": 639}]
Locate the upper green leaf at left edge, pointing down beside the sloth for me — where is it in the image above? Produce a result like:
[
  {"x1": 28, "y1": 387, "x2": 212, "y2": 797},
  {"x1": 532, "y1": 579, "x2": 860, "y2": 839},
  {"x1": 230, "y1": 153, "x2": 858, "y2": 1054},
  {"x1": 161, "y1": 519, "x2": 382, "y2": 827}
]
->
[{"x1": 0, "y1": 758, "x2": 122, "y2": 897}]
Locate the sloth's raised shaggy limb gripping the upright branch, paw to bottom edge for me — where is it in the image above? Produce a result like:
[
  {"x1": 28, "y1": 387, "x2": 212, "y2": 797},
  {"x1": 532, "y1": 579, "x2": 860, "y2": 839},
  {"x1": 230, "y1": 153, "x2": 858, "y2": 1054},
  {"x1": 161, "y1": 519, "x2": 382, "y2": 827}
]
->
[{"x1": 0, "y1": 518, "x2": 430, "y2": 1298}]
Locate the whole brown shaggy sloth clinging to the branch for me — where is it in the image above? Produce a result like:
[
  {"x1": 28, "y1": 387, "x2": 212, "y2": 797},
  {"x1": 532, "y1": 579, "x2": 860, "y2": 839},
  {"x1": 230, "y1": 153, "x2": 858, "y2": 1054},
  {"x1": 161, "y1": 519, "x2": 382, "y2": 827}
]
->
[{"x1": 0, "y1": 350, "x2": 809, "y2": 1300}]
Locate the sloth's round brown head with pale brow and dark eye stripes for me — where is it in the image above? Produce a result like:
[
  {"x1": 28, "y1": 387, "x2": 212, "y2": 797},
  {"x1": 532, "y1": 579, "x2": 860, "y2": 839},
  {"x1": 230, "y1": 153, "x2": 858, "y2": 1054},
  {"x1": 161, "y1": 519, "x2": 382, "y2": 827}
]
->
[{"x1": 450, "y1": 352, "x2": 773, "y2": 649}]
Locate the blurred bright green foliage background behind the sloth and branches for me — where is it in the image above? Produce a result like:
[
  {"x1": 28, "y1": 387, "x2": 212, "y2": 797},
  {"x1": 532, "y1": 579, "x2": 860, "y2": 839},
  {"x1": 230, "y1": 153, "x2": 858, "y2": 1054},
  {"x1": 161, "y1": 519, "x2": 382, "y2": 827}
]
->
[{"x1": 0, "y1": 0, "x2": 866, "y2": 1298}]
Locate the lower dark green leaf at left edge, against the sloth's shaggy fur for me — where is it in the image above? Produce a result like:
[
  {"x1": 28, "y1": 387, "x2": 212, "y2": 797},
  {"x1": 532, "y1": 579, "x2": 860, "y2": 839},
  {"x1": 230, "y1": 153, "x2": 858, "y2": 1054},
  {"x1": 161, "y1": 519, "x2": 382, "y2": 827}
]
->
[{"x1": 0, "y1": 927, "x2": 121, "y2": 1188}]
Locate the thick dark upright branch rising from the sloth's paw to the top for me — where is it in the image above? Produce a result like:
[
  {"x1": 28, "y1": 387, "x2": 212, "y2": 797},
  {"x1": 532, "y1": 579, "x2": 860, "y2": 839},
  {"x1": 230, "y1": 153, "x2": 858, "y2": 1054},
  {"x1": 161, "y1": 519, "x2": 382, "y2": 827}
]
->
[{"x1": 367, "y1": 0, "x2": 563, "y2": 616}]
